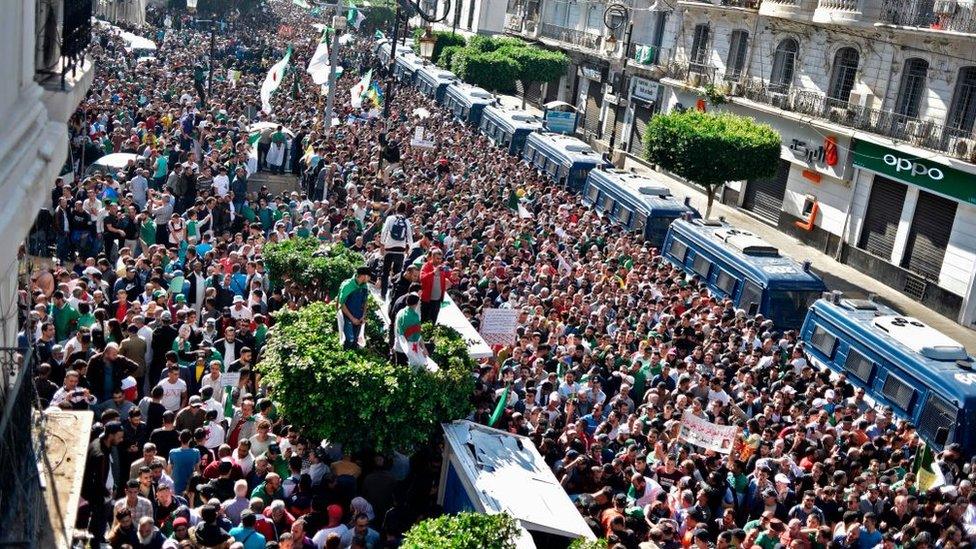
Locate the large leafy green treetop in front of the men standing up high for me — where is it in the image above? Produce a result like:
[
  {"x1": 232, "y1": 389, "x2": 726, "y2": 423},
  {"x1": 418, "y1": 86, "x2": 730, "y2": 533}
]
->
[{"x1": 257, "y1": 302, "x2": 475, "y2": 452}]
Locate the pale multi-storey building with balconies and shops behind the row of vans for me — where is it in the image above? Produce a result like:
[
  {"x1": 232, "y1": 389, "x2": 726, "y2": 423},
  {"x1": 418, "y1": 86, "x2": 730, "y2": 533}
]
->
[{"x1": 506, "y1": 0, "x2": 976, "y2": 326}]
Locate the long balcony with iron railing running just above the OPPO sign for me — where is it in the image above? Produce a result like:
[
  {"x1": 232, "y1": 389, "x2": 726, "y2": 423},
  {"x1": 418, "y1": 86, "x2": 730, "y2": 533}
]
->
[{"x1": 737, "y1": 81, "x2": 976, "y2": 162}]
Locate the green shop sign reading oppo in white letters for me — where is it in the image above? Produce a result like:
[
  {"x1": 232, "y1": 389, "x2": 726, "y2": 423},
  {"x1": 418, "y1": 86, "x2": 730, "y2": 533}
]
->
[{"x1": 853, "y1": 140, "x2": 976, "y2": 204}]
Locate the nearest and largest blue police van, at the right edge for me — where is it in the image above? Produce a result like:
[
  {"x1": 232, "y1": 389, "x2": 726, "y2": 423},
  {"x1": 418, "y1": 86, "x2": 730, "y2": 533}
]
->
[{"x1": 800, "y1": 292, "x2": 976, "y2": 455}]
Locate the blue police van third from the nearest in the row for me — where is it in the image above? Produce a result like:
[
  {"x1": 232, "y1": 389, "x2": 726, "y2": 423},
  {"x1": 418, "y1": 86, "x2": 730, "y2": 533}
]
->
[{"x1": 583, "y1": 168, "x2": 700, "y2": 247}]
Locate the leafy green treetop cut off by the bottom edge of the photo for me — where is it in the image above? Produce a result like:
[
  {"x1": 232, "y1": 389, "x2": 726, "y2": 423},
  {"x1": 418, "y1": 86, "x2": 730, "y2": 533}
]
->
[{"x1": 401, "y1": 513, "x2": 519, "y2": 549}]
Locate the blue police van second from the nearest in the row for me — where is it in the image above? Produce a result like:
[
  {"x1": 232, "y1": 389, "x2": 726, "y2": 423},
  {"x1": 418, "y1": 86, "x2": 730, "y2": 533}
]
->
[{"x1": 662, "y1": 219, "x2": 827, "y2": 329}]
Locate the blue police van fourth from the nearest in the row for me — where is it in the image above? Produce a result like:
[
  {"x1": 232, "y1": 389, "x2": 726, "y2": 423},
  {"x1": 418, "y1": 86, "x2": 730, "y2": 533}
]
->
[{"x1": 522, "y1": 132, "x2": 610, "y2": 192}]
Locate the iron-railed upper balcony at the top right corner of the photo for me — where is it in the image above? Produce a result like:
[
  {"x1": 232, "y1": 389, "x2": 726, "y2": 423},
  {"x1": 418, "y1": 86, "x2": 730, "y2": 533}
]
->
[{"x1": 880, "y1": 0, "x2": 976, "y2": 34}]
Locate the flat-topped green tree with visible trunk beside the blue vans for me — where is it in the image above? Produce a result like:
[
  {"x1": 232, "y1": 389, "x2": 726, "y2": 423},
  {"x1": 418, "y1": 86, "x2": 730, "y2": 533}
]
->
[{"x1": 644, "y1": 110, "x2": 780, "y2": 219}]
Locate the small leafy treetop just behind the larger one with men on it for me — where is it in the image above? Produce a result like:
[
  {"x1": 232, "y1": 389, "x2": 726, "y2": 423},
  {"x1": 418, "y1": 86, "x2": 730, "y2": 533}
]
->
[{"x1": 262, "y1": 238, "x2": 365, "y2": 300}]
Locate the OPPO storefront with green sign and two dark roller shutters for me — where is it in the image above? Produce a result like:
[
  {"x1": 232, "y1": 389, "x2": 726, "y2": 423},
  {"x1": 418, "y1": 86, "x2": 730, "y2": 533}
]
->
[{"x1": 843, "y1": 140, "x2": 976, "y2": 325}]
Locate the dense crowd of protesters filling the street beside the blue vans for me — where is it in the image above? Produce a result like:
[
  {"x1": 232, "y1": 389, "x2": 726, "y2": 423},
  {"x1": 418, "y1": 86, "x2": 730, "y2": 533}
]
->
[{"x1": 21, "y1": 2, "x2": 976, "y2": 549}]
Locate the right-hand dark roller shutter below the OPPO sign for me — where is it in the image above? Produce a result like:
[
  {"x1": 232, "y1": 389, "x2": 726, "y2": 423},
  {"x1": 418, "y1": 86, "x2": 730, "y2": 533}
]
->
[{"x1": 901, "y1": 191, "x2": 957, "y2": 280}]
